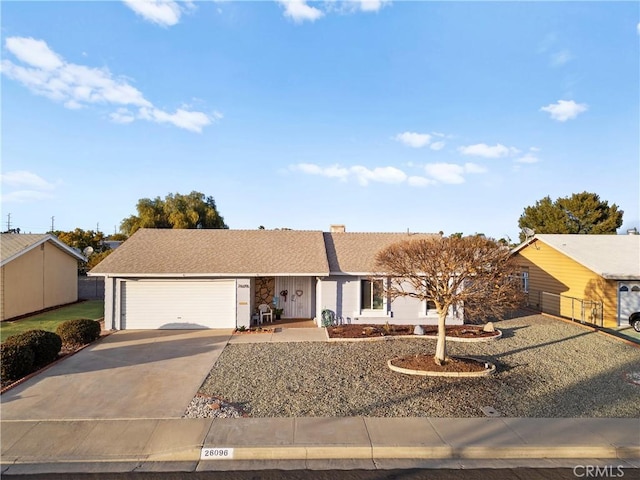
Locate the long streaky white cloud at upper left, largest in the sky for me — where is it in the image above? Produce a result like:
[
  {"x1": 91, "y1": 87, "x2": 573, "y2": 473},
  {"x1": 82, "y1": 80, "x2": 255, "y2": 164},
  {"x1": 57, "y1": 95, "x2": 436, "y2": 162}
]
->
[{"x1": 2, "y1": 37, "x2": 222, "y2": 132}]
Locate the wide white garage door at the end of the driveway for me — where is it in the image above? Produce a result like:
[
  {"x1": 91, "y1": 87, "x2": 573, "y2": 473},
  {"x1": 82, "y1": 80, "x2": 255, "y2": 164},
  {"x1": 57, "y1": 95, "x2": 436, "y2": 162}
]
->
[{"x1": 120, "y1": 280, "x2": 236, "y2": 329}]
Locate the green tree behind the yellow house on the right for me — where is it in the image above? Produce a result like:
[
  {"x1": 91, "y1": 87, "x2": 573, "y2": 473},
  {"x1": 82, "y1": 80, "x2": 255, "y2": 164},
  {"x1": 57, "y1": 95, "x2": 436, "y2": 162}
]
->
[{"x1": 518, "y1": 192, "x2": 624, "y2": 241}]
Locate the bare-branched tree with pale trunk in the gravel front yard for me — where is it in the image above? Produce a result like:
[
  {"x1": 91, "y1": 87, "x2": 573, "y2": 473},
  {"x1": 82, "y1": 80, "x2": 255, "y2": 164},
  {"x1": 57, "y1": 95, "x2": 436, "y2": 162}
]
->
[{"x1": 376, "y1": 235, "x2": 523, "y2": 365}]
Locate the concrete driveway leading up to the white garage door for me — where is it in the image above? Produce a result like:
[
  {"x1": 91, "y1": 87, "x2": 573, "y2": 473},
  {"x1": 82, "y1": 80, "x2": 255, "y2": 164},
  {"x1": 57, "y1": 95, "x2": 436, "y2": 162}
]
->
[{"x1": 1, "y1": 329, "x2": 232, "y2": 420}]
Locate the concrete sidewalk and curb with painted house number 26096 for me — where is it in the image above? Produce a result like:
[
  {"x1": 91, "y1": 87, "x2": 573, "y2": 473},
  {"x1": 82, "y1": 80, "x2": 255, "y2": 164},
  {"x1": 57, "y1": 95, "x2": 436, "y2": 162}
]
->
[{"x1": 1, "y1": 417, "x2": 640, "y2": 474}]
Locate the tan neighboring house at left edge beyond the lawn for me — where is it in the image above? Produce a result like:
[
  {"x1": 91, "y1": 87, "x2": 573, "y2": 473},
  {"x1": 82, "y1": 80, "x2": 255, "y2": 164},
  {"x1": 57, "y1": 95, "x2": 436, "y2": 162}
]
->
[{"x1": 0, "y1": 233, "x2": 86, "y2": 321}]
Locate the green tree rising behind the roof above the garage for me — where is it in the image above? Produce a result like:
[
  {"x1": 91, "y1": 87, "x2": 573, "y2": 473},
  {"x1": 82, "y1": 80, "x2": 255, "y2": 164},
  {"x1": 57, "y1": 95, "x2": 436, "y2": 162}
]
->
[{"x1": 120, "y1": 191, "x2": 229, "y2": 236}]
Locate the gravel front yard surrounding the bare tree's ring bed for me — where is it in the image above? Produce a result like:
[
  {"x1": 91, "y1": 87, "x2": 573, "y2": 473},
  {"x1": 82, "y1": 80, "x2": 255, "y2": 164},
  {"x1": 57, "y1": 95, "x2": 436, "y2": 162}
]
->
[{"x1": 185, "y1": 315, "x2": 640, "y2": 417}]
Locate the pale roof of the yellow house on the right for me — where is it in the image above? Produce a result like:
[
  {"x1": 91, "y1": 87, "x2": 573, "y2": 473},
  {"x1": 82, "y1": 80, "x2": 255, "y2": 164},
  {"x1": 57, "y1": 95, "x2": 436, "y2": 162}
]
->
[{"x1": 515, "y1": 234, "x2": 640, "y2": 280}]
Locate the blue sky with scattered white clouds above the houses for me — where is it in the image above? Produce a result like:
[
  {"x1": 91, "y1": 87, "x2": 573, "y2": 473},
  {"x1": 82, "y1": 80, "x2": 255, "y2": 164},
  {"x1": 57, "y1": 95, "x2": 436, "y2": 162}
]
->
[{"x1": 1, "y1": 0, "x2": 640, "y2": 240}]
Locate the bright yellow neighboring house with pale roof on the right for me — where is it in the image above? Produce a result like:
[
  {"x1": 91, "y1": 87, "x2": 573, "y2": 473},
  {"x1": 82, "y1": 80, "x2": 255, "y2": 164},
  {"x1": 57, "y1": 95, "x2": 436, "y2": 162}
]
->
[{"x1": 513, "y1": 234, "x2": 640, "y2": 327}]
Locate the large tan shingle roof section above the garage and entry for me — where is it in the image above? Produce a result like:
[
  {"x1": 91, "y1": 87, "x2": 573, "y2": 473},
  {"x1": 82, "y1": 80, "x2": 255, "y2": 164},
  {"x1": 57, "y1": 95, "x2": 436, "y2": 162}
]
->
[{"x1": 90, "y1": 229, "x2": 329, "y2": 276}]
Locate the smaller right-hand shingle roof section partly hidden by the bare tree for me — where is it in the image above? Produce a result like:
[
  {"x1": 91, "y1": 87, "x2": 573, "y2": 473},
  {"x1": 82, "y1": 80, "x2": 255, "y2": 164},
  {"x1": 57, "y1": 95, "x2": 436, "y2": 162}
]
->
[{"x1": 324, "y1": 232, "x2": 439, "y2": 274}]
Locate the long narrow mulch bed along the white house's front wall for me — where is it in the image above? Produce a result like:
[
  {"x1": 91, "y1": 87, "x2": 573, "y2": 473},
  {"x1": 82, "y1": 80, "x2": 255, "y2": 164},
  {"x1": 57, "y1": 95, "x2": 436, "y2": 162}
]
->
[{"x1": 327, "y1": 324, "x2": 497, "y2": 338}]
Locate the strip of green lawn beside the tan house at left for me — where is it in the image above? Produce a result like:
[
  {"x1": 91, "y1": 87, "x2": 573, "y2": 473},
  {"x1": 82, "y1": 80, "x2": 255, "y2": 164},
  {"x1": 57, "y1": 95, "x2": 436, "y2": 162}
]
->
[{"x1": 0, "y1": 300, "x2": 104, "y2": 342}]
